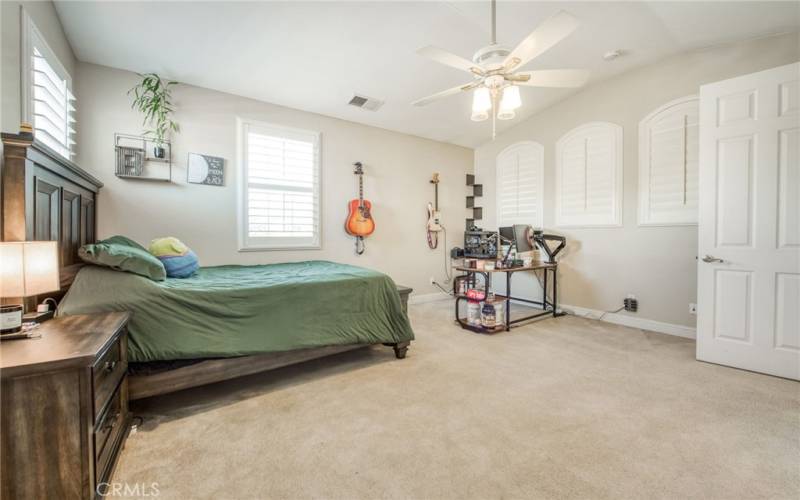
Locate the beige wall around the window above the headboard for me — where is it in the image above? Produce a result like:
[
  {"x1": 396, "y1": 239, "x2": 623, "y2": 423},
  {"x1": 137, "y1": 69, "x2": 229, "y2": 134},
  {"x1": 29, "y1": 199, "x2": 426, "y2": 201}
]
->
[{"x1": 0, "y1": 0, "x2": 80, "y2": 133}]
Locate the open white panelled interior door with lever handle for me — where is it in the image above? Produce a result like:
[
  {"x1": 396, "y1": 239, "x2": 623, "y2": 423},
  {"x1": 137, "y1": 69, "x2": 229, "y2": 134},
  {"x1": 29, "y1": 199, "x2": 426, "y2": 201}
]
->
[{"x1": 697, "y1": 63, "x2": 800, "y2": 380}]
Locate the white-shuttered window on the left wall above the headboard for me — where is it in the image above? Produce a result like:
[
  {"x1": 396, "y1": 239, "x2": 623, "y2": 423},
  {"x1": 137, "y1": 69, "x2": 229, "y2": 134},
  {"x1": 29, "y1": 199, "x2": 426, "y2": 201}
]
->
[{"x1": 22, "y1": 10, "x2": 75, "y2": 159}]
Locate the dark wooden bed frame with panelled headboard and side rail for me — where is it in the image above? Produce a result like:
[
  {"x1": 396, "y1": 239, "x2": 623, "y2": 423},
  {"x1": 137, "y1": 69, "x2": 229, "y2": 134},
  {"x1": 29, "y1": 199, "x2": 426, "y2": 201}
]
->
[{"x1": 0, "y1": 133, "x2": 411, "y2": 399}]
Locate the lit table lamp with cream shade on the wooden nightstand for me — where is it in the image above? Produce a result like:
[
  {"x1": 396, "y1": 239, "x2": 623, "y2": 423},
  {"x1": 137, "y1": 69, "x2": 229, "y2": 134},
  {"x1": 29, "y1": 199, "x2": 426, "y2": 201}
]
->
[{"x1": 0, "y1": 241, "x2": 61, "y2": 335}]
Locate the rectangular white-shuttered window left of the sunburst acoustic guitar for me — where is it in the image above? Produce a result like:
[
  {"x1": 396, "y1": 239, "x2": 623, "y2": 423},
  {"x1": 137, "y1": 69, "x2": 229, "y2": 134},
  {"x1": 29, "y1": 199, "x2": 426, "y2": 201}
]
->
[{"x1": 239, "y1": 121, "x2": 320, "y2": 250}]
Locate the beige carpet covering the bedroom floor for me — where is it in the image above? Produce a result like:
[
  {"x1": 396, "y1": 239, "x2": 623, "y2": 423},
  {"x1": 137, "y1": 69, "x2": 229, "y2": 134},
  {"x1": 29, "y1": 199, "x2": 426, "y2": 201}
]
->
[{"x1": 114, "y1": 302, "x2": 800, "y2": 499}]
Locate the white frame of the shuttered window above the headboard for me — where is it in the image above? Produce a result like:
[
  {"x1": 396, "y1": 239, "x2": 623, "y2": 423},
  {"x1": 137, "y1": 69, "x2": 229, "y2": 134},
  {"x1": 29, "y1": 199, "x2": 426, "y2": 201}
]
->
[{"x1": 20, "y1": 8, "x2": 77, "y2": 160}]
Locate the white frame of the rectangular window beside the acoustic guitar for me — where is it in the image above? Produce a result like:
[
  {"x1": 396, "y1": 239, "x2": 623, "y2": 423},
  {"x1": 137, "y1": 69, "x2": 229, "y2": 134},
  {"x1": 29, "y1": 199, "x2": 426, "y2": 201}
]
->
[{"x1": 236, "y1": 117, "x2": 323, "y2": 252}]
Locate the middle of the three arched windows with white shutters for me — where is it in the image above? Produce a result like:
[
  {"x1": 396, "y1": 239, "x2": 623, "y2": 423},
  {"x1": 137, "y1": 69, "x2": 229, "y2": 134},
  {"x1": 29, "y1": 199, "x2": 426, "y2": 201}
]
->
[{"x1": 556, "y1": 122, "x2": 622, "y2": 227}]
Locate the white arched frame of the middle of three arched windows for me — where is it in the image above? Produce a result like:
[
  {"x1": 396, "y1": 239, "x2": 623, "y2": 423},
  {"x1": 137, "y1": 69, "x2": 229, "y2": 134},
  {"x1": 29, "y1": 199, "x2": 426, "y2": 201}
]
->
[{"x1": 555, "y1": 121, "x2": 625, "y2": 228}]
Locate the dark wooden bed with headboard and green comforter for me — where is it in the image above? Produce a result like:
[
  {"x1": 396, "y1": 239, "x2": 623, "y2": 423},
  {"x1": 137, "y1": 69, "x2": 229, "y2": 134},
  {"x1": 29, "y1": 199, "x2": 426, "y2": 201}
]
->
[{"x1": 1, "y1": 134, "x2": 414, "y2": 399}]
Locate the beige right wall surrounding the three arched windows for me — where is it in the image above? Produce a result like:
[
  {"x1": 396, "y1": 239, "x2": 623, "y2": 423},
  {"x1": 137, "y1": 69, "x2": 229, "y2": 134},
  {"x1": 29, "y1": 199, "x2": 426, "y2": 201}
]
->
[{"x1": 475, "y1": 33, "x2": 800, "y2": 326}]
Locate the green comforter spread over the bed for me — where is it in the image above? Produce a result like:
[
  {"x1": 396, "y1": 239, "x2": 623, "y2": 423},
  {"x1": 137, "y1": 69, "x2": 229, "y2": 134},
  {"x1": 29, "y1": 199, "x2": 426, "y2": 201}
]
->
[{"x1": 58, "y1": 261, "x2": 414, "y2": 361}]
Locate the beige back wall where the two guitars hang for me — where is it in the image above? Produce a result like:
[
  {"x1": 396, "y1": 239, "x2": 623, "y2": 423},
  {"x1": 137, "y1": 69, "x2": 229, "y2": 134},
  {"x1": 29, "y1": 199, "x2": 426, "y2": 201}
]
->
[{"x1": 76, "y1": 63, "x2": 473, "y2": 294}]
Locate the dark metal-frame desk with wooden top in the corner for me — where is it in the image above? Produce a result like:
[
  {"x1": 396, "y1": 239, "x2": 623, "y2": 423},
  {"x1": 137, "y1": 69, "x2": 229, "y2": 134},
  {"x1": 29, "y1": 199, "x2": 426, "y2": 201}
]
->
[{"x1": 454, "y1": 262, "x2": 564, "y2": 333}]
